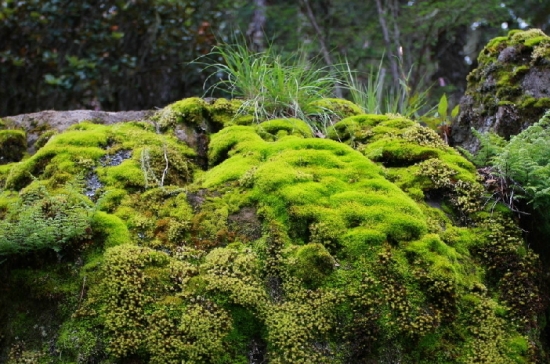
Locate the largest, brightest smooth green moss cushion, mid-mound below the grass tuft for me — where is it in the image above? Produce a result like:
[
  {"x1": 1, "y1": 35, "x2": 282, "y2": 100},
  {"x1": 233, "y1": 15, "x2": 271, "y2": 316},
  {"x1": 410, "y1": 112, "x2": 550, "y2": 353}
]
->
[{"x1": 199, "y1": 121, "x2": 425, "y2": 253}]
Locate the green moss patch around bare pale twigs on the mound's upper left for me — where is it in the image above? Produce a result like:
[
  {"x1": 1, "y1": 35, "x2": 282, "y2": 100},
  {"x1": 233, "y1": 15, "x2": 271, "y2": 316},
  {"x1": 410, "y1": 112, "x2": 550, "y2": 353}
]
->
[{"x1": 6, "y1": 122, "x2": 195, "y2": 190}]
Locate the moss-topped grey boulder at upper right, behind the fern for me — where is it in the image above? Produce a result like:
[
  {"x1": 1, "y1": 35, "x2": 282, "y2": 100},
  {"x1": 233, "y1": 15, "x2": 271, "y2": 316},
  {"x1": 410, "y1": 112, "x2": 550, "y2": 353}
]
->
[{"x1": 451, "y1": 29, "x2": 550, "y2": 152}]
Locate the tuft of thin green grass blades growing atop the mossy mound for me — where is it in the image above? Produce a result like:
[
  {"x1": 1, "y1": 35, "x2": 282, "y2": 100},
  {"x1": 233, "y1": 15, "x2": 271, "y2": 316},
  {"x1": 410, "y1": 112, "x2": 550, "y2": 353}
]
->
[{"x1": 202, "y1": 38, "x2": 340, "y2": 135}]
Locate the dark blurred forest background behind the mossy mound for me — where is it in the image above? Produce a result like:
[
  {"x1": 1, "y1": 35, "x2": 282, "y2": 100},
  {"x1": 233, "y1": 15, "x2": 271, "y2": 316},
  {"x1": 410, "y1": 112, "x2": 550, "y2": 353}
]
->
[{"x1": 0, "y1": 0, "x2": 550, "y2": 116}]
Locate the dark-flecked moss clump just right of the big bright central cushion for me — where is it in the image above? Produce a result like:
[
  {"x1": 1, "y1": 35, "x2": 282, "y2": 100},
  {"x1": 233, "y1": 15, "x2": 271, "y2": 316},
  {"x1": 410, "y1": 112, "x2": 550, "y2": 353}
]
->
[{"x1": 328, "y1": 115, "x2": 483, "y2": 217}]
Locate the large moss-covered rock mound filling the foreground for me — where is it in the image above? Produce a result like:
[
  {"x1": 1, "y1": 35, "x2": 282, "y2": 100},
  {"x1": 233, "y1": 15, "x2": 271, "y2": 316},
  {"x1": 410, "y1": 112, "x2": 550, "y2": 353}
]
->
[{"x1": 0, "y1": 99, "x2": 547, "y2": 363}]
